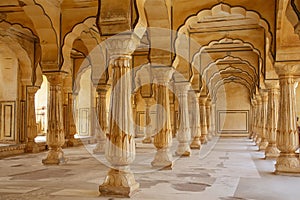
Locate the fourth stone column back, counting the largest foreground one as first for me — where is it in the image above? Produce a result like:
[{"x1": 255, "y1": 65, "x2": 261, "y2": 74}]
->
[{"x1": 190, "y1": 91, "x2": 201, "y2": 149}]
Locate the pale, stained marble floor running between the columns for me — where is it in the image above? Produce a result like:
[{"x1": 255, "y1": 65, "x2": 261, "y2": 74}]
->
[{"x1": 0, "y1": 137, "x2": 300, "y2": 200}]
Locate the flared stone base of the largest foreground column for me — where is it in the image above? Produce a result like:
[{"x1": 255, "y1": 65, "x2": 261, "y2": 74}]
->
[{"x1": 99, "y1": 169, "x2": 140, "y2": 197}]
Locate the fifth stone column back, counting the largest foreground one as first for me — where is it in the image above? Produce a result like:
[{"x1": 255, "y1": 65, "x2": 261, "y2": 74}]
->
[{"x1": 199, "y1": 96, "x2": 208, "y2": 144}]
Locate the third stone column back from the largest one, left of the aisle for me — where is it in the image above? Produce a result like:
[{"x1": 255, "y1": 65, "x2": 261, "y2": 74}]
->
[{"x1": 175, "y1": 82, "x2": 191, "y2": 156}]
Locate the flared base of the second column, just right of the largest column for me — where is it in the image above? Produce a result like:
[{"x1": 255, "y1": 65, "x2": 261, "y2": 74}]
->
[{"x1": 151, "y1": 149, "x2": 173, "y2": 170}]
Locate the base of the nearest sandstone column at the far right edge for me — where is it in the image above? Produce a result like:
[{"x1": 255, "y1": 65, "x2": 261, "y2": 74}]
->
[{"x1": 275, "y1": 153, "x2": 300, "y2": 175}]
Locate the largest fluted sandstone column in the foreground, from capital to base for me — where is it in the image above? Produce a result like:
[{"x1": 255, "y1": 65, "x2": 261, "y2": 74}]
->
[{"x1": 99, "y1": 35, "x2": 139, "y2": 197}]
